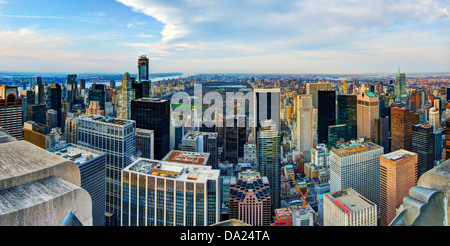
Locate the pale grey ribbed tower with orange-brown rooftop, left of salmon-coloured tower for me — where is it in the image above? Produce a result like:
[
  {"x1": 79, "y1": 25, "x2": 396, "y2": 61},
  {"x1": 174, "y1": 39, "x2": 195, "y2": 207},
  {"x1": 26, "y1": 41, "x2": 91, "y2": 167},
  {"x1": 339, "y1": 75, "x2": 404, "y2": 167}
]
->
[{"x1": 329, "y1": 142, "x2": 384, "y2": 204}]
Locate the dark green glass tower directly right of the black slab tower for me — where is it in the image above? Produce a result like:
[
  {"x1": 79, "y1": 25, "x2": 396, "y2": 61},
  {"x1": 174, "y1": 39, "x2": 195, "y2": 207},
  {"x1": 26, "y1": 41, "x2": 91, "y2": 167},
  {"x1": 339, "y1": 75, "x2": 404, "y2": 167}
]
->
[{"x1": 337, "y1": 94, "x2": 358, "y2": 141}]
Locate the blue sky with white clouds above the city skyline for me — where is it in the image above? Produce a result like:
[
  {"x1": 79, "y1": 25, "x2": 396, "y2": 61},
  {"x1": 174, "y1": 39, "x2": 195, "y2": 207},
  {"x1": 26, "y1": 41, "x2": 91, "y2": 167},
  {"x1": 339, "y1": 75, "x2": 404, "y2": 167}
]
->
[{"x1": 0, "y1": 0, "x2": 450, "y2": 74}]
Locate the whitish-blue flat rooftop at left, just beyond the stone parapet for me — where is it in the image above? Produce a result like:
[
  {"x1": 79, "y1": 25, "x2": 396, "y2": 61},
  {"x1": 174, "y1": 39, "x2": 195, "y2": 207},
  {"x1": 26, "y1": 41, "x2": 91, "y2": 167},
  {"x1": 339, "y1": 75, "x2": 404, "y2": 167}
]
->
[{"x1": 48, "y1": 144, "x2": 103, "y2": 165}]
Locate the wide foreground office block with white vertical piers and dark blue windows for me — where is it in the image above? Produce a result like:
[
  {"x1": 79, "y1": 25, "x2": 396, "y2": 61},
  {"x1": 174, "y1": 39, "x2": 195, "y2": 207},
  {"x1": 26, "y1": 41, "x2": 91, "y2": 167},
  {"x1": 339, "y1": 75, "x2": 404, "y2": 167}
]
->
[{"x1": 121, "y1": 158, "x2": 221, "y2": 226}]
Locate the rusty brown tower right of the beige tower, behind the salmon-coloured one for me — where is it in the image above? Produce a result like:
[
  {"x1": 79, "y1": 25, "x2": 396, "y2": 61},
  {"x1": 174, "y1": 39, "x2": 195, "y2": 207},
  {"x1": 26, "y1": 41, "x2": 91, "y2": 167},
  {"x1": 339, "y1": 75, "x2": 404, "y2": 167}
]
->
[{"x1": 391, "y1": 106, "x2": 419, "y2": 151}]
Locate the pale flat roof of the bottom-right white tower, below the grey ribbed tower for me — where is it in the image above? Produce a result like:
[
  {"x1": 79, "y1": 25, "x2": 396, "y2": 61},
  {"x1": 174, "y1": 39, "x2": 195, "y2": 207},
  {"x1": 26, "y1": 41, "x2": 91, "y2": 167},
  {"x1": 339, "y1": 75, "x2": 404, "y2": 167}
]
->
[{"x1": 325, "y1": 189, "x2": 375, "y2": 213}]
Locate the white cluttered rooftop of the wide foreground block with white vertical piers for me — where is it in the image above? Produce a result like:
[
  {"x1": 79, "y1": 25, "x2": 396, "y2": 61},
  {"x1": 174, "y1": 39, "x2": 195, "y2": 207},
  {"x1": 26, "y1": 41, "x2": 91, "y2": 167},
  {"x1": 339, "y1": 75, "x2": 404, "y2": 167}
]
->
[{"x1": 123, "y1": 158, "x2": 220, "y2": 183}]
